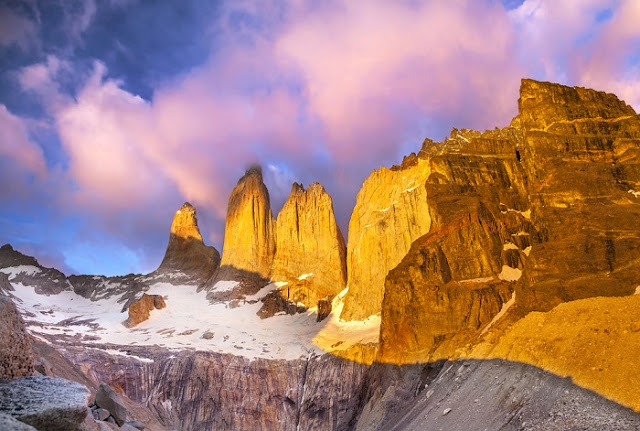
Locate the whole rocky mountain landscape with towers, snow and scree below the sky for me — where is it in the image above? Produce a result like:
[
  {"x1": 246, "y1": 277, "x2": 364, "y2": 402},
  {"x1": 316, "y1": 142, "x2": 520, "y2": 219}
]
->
[{"x1": 0, "y1": 80, "x2": 640, "y2": 430}]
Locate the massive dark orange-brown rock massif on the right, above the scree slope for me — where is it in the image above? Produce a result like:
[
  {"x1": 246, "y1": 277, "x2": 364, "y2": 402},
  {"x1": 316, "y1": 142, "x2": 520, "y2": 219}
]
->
[{"x1": 380, "y1": 80, "x2": 640, "y2": 362}]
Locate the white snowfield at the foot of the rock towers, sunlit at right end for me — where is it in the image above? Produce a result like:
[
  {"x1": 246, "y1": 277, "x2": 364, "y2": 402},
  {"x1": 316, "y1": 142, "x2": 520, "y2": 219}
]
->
[{"x1": 0, "y1": 267, "x2": 380, "y2": 361}]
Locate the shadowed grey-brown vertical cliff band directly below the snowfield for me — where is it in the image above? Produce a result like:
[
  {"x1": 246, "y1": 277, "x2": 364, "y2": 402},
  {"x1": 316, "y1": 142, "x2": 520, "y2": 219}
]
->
[{"x1": 60, "y1": 347, "x2": 368, "y2": 431}]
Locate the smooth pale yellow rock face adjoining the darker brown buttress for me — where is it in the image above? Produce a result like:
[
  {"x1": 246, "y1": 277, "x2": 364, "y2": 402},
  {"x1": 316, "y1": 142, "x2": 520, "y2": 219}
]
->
[{"x1": 341, "y1": 154, "x2": 431, "y2": 320}]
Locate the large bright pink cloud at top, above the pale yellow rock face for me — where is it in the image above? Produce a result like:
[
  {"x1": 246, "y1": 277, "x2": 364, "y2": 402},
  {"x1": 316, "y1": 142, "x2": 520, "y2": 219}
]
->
[{"x1": 277, "y1": 1, "x2": 522, "y2": 159}]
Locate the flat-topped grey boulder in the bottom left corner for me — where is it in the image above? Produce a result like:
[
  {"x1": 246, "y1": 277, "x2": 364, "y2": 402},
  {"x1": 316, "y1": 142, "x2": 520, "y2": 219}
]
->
[{"x1": 0, "y1": 376, "x2": 89, "y2": 431}]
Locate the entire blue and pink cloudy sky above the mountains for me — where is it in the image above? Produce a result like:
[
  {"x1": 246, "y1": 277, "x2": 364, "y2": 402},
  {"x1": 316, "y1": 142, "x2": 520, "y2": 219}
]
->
[{"x1": 0, "y1": 0, "x2": 640, "y2": 275}]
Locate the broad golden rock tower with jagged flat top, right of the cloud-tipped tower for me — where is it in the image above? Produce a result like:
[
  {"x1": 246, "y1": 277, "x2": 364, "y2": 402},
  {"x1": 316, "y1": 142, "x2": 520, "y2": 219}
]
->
[{"x1": 271, "y1": 183, "x2": 346, "y2": 307}]
